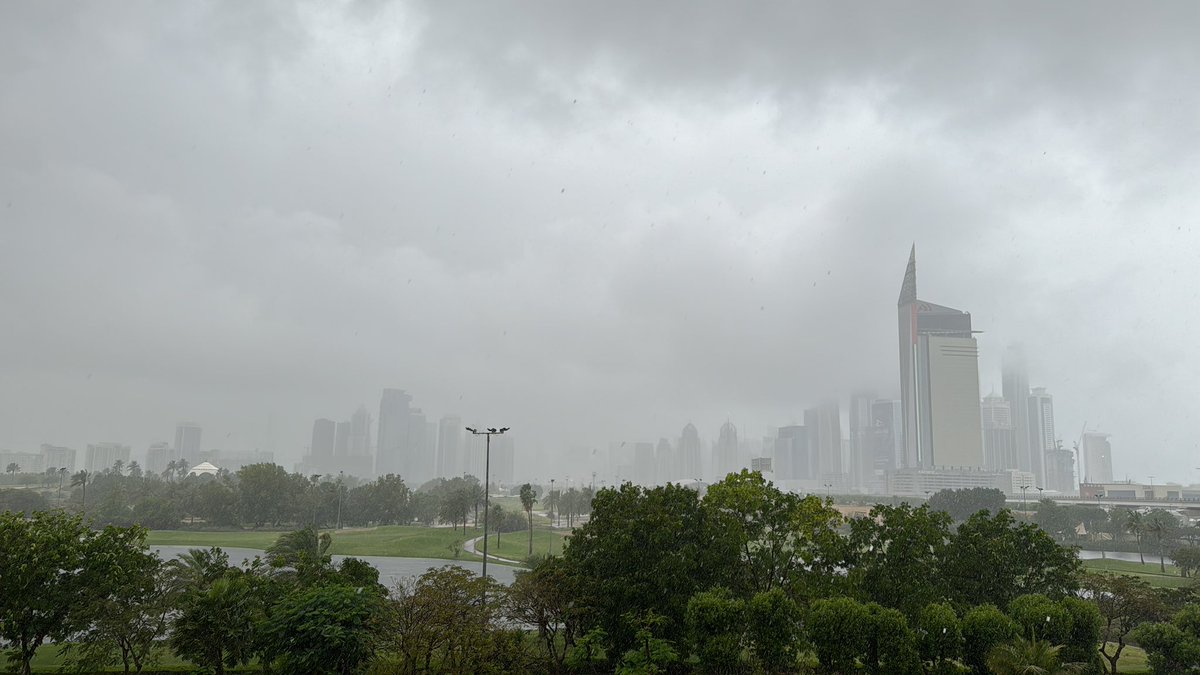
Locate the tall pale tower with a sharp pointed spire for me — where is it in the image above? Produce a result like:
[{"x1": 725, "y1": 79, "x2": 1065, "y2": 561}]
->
[{"x1": 896, "y1": 246, "x2": 983, "y2": 468}]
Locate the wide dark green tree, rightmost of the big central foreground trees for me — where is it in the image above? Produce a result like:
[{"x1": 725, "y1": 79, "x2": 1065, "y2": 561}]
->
[{"x1": 940, "y1": 510, "x2": 1081, "y2": 607}]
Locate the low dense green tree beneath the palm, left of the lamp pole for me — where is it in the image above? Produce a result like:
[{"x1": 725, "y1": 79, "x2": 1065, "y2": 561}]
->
[{"x1": 258, "y1": 584, "x2": 380, "y2": 675}]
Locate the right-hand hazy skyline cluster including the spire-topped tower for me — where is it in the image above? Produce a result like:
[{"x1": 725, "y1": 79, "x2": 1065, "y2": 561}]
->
[{"x1": 600, "y1": 249, "x2": 1112, "y2": 495}]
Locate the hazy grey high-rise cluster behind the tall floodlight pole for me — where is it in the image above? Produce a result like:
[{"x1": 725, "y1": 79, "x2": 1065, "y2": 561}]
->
[{"x1": 296, "y1": 389, "x2": 516, "y2": 488}]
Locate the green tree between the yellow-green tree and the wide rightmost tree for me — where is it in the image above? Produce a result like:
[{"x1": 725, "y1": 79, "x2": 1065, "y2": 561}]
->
[{"x1": 847, "y1": 503, "x2": 950, "y2": 617}]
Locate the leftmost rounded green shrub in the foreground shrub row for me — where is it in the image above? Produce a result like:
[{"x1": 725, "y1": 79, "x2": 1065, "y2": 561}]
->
[{"x1": 684, "y1": 586, "x2": 746, "y2": 673}]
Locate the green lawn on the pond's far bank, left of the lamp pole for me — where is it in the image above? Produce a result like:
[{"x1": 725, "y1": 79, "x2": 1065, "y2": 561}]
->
[{"x1": 146, "y1": 525, "x2": 479, "y2": 558}]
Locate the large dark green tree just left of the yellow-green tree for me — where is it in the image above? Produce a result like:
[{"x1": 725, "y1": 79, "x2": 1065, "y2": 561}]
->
[{"x1": 565, "y1": 483, "x2": 739, "y2": 653}]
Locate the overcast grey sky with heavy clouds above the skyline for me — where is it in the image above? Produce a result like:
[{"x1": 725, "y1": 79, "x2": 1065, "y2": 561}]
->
[{"x1": 0, "y1": 0, "x2": 1200, "y2": 482}]
